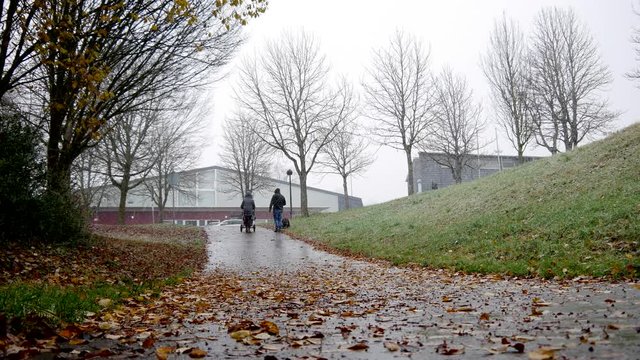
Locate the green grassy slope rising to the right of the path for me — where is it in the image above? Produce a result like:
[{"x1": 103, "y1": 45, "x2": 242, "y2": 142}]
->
[{"x1": 290, "y1": 124, "x2": 640, "y2": 278}]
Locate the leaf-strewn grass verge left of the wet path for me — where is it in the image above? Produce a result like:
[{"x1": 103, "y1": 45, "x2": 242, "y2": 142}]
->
[{"x1": 0, "y1": 225, "x2": 206, "y2": 336}]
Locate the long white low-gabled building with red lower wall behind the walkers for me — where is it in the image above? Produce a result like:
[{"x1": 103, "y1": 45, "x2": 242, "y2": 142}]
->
[{"x1": 93, "y1": 166, "x2": 362, "y2": 225}]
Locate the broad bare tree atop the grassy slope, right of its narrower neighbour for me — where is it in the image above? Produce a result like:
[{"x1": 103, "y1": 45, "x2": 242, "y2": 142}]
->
[{"x1": 528, "y1": 8, "x2": 617, "y2": 153}]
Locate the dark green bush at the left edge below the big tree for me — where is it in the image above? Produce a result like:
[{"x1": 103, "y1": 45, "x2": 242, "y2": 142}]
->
[{"x1": 0, "y1": 103, "x2": 88, "y2": 243}]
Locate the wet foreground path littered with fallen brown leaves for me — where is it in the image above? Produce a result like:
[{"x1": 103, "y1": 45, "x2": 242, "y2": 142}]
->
[{"x1": 4, "y1": 229, "x2": 640, "y2": 360}]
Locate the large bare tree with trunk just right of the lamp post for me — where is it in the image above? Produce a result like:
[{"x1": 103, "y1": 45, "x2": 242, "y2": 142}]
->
[{"x1": 237, "y1": 32, "x2": 347, "y2": 216}]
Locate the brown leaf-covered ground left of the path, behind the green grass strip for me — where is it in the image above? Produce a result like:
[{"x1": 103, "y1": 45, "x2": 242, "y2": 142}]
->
[{"x1": 0, "y1": 226, "x2": 206, "y2": 285}]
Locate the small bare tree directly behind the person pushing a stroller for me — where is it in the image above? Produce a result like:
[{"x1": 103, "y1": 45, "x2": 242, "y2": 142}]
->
[{"x1": 220, "y1": 112, "x2": 273, "y2": 197}]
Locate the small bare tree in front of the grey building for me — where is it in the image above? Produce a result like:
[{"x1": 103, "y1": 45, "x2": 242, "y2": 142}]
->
[{"x1": 424, "y1": 68, "x2": 482, "y2": 183}]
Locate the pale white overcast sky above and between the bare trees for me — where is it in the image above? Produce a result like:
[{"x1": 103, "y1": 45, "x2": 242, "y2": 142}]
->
[{"x1": 200, "y1": 0, "x2": 640, "y2": 205}]
